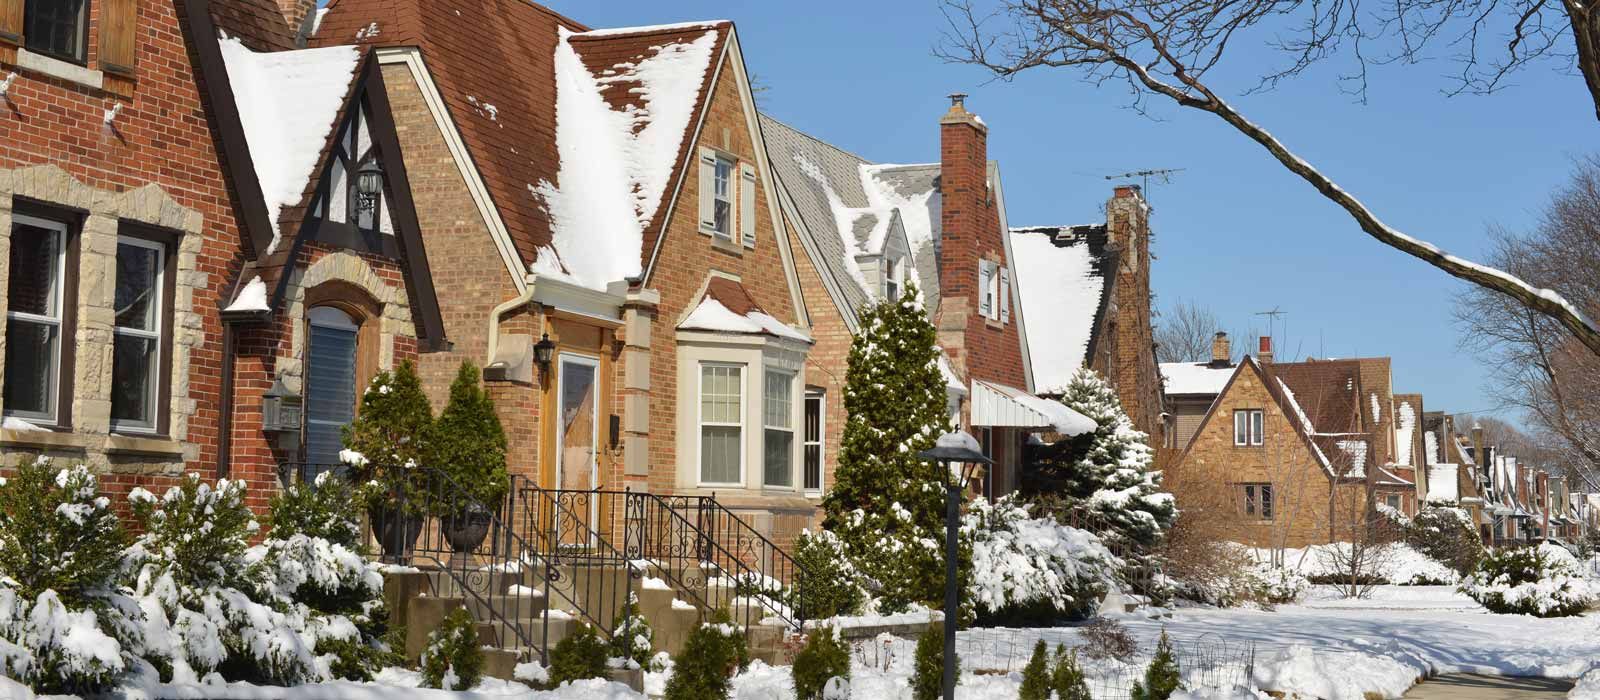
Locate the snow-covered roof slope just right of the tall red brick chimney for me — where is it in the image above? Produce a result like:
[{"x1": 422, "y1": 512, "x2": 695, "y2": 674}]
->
[{"x1": 1010, "y1": 229, "x2": 1106, "y2": 393}]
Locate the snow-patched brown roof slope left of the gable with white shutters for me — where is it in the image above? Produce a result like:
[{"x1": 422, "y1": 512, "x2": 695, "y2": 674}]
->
[{"x1": 528, "y1": 24, "x2": 720, "y2": 289}]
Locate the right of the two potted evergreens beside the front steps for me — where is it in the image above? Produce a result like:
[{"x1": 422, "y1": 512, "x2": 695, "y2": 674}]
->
[{"x1": 427, "y1": 360, "x2": 509, "y2": 508}]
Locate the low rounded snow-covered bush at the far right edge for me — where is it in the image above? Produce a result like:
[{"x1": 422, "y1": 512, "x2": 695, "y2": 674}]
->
[{"x1": 1461, "y1": 547, "x2": 1595, "y2": 617}]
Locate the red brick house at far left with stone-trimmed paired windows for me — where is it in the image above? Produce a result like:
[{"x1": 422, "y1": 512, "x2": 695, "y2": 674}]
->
[{"x1": 0, "y1": 0, "x2": 300, "y2": 505}]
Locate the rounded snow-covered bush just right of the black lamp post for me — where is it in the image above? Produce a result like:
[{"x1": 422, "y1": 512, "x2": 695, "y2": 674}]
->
[{"x1": 962, "y1": 495, "x2": 1122, "y2": 622}]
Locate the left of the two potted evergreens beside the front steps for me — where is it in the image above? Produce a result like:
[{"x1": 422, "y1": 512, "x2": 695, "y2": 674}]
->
[{"x1": 344, "y1": 360, "x2": 434, "y2": 508}]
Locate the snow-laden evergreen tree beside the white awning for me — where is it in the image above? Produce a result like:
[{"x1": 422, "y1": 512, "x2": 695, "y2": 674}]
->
[{"x1": 1027, "y1": 368, "x2": 1176, "y2": 551}]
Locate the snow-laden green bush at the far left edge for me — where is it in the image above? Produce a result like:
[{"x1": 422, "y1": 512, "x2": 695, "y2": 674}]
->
[{"x1": 0, "y1": 459, "x2": 142, "y2": 694}]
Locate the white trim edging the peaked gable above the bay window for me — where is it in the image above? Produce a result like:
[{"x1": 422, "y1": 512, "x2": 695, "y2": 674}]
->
[{"x1": 643, "y1": 27, "x2": 811, "y2": 328}]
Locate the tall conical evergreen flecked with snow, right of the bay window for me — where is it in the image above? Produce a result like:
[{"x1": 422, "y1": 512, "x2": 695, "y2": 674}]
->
[{"x1": 822, "y1": 286, "x2": 950, "y2": 612}]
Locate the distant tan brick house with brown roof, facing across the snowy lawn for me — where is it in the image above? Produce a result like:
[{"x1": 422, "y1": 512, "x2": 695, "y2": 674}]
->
[{"x1": 1168, "y1": 356, "x2": 1371, "y2": 547}]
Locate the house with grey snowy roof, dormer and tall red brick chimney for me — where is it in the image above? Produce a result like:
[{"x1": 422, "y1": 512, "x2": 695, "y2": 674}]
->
[{"x1": 762, "y1": 96, "x2": 1085, "y2": 495}]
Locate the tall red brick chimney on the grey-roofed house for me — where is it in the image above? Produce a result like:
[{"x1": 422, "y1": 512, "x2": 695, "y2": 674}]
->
[{"x1": 936, "y1": 93, "x2": 985, "y2": 361}]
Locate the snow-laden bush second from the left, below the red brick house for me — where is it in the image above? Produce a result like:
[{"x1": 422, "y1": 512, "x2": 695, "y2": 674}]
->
[{"x1": 128, "y1": 475, "x2": 318, "y2": 684}]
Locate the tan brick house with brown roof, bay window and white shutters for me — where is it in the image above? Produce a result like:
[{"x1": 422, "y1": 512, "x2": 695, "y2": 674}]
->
[{"x1": 309, "y1": 0, "x2": 842, "y2": 543}]
